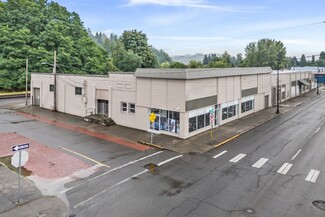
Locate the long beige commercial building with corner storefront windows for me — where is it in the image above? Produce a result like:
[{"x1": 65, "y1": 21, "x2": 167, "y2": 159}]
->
[{"x1": 31, "y1": 67, "x2": 314, "y2": 139}]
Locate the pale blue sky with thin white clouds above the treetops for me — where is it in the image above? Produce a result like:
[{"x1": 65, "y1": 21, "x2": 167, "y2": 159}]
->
[{"x1": 56, "y1": 0, "x2": 325, "y2": 57}]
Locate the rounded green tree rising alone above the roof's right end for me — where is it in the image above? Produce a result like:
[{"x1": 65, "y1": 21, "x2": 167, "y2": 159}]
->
[{"x1": 245, "y1": 39, "x2": 286, "y2": 69}]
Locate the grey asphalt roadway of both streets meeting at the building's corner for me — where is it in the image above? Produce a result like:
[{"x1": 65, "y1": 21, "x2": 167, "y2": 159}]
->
[{"x1": 0, "y1": 95, "x2": 325, "y2": 217}]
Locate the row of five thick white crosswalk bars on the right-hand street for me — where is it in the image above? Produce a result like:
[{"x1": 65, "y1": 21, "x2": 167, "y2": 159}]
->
[{"x1": 213, "y1": 150, "x2": 320, "y2": 183}]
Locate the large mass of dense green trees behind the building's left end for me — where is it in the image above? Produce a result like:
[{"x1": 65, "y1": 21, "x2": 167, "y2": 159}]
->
[{"x1": 0, "y1": 0, "x2": 109, "y2": 90}]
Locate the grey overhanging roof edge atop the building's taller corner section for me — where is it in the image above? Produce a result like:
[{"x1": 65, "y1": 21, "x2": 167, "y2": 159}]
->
[{"x1": 135, "y1": 67, "x2": 272, "y2": 80}]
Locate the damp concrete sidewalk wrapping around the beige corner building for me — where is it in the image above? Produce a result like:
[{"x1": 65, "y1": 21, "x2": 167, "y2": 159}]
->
[{"x1": 11, "y1": 90, "x2": 317, "y2": 154}]
